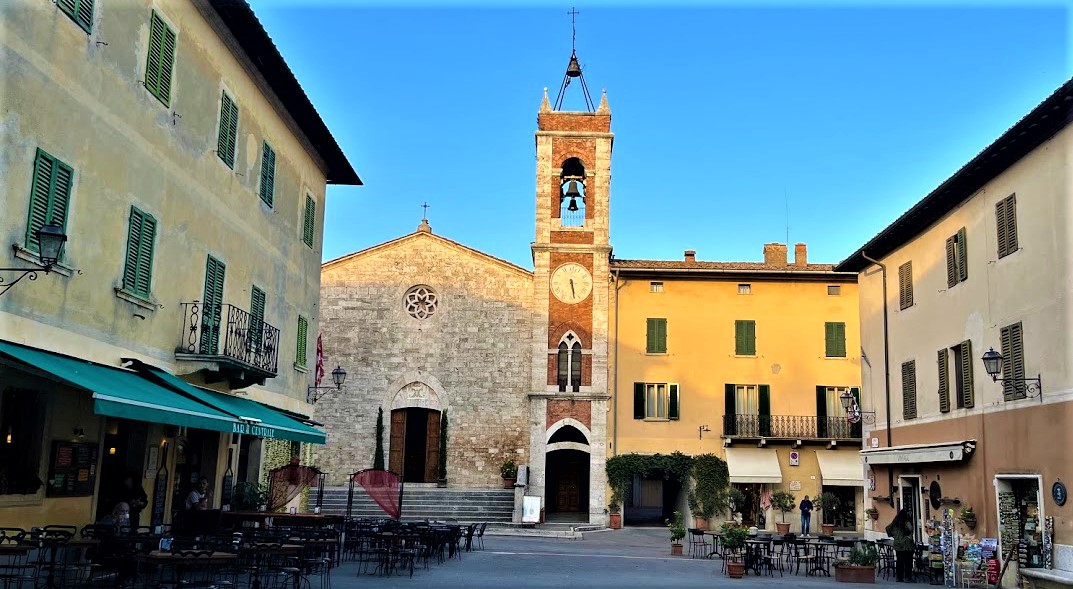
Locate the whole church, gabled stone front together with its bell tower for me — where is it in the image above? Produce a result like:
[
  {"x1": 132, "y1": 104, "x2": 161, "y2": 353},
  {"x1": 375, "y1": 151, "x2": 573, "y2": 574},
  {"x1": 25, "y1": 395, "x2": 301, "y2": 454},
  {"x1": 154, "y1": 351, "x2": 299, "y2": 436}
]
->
[{"x1": 317, "y1": 84, "x2": 614, "y2": 524}]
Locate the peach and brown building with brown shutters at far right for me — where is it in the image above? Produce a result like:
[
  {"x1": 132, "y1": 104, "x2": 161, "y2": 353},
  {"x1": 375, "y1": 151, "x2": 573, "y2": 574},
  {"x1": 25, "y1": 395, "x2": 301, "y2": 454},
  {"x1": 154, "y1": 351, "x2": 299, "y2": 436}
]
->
[{"x1": 836, "y1": 76, "x2": 1073, "y2": 587}]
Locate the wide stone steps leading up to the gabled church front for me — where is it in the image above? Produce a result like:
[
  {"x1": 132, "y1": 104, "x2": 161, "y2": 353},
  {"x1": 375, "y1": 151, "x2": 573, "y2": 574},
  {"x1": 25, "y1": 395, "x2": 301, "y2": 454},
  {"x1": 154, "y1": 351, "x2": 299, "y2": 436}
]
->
[{"x1": 321, "y1": 487, "x2": 514, "y2": 522}]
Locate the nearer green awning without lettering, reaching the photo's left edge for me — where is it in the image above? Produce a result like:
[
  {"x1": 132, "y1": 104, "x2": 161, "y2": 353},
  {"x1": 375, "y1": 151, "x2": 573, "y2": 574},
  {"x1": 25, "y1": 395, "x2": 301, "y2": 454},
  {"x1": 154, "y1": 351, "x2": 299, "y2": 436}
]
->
[{"x1": 0, "y1": 340, "x2": 241, "y2": 431}]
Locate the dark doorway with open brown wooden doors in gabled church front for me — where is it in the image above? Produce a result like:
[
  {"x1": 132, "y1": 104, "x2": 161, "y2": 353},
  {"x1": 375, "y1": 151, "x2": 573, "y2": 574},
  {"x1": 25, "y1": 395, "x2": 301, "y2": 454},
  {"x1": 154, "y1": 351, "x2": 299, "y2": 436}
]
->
[{"x1": 387, "y1": 407, "x2": 440, "y2": 483}]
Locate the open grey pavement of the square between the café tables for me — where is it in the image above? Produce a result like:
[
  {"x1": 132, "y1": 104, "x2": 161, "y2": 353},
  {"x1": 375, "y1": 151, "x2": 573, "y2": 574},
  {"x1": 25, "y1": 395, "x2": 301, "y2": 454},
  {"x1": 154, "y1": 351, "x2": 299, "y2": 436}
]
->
[{"x1": 332, "y1": 528, "x2": 939, "y2": 589}]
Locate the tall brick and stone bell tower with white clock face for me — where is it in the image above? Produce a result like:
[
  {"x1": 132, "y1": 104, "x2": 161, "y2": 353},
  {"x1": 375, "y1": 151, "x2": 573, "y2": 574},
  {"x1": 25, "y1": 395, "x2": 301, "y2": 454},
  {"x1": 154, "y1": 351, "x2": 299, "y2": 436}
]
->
[{"x1": 527, "y1": 27, "x2": 614, "y2": 525}]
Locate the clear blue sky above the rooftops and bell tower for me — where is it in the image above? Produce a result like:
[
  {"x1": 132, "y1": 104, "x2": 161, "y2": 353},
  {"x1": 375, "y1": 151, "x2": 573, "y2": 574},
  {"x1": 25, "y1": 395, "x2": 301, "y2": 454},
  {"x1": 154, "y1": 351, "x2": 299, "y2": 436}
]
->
[{"x1": 252, "y1": 0, "x2": 1071, "y2": 268}]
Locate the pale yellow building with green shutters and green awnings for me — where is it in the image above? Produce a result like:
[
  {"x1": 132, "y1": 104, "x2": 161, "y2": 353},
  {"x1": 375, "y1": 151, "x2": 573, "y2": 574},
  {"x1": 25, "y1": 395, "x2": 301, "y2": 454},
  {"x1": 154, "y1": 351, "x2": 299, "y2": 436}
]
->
[{"x1": 0, "y1": 0, "x2": 361, "y2": 528}]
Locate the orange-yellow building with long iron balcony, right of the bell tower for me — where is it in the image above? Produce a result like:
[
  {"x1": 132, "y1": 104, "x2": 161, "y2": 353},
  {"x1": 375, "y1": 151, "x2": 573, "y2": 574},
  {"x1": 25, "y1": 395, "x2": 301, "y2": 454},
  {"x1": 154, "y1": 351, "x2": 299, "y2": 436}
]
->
[{"x1": 608, "y1": 244, "x2": 869, "y2": 533}]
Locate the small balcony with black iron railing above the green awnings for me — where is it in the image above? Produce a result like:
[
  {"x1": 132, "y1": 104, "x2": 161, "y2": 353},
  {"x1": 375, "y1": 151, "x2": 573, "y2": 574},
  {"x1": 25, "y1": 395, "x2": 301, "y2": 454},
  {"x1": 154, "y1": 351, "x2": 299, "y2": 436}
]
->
[{"x1": 175, "y1": 300, "x2": 279, "y2": 388}]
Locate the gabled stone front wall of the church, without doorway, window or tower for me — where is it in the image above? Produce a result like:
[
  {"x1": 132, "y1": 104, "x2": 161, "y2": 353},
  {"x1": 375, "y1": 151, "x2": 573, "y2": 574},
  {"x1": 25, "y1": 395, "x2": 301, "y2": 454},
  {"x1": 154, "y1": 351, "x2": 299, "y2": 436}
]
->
[{"x1": 315, "y1": 233, "x2": 533, "y2": 487}]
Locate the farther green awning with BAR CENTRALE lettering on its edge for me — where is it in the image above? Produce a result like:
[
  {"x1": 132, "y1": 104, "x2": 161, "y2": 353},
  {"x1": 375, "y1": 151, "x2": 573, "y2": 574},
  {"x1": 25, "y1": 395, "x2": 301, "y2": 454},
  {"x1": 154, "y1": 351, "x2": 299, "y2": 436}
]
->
[{"x1": 135, "y1": 362, "x2": 327, "y2": 444}]
